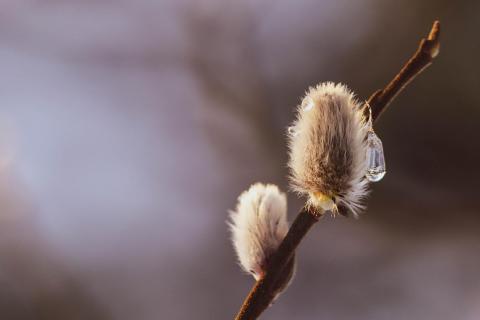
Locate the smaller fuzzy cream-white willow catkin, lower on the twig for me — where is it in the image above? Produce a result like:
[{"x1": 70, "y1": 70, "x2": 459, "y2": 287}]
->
[{"x1": 229, "y1": 183, "x2": 288, "y2": 280}]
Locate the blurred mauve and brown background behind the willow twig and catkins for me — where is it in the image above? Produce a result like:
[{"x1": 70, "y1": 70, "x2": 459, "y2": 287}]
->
[{"x1": 0, "y1": 0, "x2": 480, "y2": 320}]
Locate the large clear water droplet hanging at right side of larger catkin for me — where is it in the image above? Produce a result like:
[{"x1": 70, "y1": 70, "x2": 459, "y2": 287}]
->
[{"x1": 366, "y1": 131, "x2": 387, "y2": 182}]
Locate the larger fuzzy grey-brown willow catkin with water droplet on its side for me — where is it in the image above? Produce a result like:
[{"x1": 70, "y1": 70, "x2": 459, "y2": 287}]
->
[{"x1": 288, "y1": 82, "x2": 368, "y2": 216}]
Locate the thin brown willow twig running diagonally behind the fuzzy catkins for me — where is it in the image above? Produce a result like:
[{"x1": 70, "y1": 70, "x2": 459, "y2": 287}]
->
[{"x1": 235, "y1": 21, "x2": 440, "y2": 320}]
